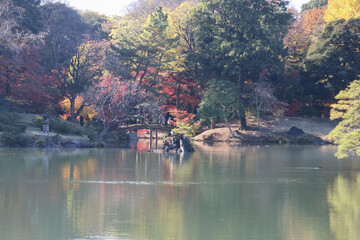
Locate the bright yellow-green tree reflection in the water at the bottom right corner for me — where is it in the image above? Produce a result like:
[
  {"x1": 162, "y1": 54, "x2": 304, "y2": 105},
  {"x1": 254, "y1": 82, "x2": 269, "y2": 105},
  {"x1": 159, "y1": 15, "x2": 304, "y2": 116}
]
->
[{"x1": 328, "y1": 173, "x2": 360, "y2": 240}]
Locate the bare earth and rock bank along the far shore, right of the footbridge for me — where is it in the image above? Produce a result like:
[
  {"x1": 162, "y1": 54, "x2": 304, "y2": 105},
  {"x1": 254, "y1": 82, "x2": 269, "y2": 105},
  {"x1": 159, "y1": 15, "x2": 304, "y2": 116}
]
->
[{"x1": 193, "y1": 117, "x2": 336, "y2": 145}]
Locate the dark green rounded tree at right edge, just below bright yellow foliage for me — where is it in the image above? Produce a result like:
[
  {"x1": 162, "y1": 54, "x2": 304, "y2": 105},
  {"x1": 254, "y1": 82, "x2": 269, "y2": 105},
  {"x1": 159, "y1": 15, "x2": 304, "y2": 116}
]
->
[{"x1": 302, "y1": 18, "x2": 360, "y2": 107}]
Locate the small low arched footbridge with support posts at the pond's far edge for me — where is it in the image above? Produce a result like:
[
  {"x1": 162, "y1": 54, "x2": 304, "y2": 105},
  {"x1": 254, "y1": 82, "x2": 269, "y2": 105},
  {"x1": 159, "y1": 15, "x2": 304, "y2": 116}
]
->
[{"x1": 117, "y1": 124, "x2": 174, "y2": 149}]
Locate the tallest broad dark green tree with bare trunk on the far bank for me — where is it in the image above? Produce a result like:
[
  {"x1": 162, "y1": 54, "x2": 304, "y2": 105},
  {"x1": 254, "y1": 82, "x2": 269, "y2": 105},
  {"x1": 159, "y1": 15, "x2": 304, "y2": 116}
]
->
[{"x1": 191, "y1": 0, "x2": 291, "y2": 129}]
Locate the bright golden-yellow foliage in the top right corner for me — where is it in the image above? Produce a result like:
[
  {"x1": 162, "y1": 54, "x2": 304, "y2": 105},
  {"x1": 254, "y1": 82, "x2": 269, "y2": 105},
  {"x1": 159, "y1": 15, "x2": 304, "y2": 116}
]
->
[{"x1": 324, "y1": 0, "x2": 360, "y2": 22}]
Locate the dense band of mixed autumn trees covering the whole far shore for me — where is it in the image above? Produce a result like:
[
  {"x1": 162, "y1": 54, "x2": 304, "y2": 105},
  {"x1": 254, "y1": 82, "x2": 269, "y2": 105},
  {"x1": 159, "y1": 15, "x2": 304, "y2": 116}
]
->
[{"x1": 0, "y1": 0, "x2": 360, "y2": 155}]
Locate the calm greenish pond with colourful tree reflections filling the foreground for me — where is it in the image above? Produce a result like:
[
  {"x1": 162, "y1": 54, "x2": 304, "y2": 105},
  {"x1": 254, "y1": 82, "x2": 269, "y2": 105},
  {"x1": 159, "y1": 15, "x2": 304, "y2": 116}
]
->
[{"x1": 0, "y1": 143, "x2": 360, "y2": 240}]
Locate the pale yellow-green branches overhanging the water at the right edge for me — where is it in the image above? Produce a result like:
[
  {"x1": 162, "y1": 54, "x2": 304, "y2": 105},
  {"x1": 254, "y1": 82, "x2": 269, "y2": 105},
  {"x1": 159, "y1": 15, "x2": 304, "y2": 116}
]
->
[{"x1": 329, "y1": 80, "x2": 360, "y2": 158}]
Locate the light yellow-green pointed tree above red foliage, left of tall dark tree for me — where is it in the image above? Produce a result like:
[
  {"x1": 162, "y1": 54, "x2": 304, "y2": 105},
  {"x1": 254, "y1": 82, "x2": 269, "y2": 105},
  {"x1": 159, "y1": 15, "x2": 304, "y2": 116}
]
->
[{"x1": 109, "y1": 7, "x2": 178, "y2": 90}]
